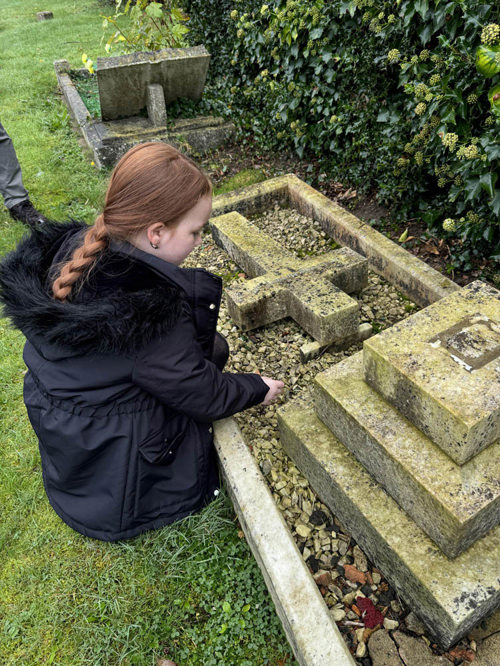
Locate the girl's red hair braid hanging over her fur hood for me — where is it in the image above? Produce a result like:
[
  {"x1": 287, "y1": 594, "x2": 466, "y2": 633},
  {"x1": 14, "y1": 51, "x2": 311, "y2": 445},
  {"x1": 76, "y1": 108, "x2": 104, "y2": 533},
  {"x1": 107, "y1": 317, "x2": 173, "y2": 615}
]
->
[{"x1": 52, "y1": 214, "x2": 108, "y2": 301}]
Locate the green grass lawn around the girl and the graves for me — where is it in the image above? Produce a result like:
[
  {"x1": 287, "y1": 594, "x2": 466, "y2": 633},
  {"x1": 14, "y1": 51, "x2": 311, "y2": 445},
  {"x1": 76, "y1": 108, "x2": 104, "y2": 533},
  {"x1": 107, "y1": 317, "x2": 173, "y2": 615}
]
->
[{"x1": 0, "y1": 0, "x2": 294, "y2": 666}]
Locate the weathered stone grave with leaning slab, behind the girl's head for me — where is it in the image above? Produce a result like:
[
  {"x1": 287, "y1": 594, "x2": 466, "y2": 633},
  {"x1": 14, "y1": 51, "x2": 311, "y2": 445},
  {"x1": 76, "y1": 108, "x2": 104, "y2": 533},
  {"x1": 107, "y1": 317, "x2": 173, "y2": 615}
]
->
[{"x1": 54, "y1": 46, "x2": 234, "y2": 167}]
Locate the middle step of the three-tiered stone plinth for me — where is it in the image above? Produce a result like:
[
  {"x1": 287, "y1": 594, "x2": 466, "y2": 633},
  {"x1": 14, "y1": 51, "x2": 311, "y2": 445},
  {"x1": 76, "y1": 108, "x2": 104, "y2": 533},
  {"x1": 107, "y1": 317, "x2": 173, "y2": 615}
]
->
[{"x1": 315, "y1": 352, "x2": 500, "y2": 558}]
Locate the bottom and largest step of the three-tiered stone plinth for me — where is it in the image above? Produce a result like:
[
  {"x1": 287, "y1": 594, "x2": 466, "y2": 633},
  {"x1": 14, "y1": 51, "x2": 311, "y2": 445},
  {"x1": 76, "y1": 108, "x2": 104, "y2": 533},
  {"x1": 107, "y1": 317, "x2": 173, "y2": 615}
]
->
[{"x1": 278, "y1": 402, "x2": 500, "y2": 649}]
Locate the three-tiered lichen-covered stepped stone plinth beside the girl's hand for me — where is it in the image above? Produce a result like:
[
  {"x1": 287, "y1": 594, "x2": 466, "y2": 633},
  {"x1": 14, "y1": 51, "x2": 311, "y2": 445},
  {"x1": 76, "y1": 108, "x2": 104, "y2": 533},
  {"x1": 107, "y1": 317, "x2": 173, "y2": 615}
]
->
[{"x1": 279, "y1": 282, "x2": 500, "y2": 648}]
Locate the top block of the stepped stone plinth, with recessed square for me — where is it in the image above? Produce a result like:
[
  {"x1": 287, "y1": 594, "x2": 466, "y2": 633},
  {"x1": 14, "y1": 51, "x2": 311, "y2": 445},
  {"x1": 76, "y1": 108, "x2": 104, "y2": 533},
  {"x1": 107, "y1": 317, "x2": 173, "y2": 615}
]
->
[{"x1": 364, "y1": 281, "x2": 500, "y2": 465}]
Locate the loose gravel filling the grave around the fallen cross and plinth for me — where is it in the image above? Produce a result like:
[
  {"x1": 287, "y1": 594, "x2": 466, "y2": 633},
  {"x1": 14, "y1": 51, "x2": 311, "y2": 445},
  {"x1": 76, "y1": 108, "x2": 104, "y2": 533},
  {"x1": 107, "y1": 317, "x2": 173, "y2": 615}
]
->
[{"x1": 183, "y1": 206, "x2": 476, "y2": 666}]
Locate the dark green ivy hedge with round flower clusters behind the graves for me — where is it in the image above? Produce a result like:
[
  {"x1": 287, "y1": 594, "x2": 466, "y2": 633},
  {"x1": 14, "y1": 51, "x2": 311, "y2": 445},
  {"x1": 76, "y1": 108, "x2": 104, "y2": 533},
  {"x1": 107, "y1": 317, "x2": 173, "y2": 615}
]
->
[{"x1": 182, "y1": 0, "x2": 500, "y2": 269}]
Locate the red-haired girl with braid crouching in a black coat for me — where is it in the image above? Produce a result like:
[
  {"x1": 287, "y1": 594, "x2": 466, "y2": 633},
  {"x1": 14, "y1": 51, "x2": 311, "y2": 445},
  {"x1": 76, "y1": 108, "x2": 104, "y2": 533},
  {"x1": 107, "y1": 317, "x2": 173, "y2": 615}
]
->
[{"x1": 0, "y1": 143, "x2": 283, "y2": 541}]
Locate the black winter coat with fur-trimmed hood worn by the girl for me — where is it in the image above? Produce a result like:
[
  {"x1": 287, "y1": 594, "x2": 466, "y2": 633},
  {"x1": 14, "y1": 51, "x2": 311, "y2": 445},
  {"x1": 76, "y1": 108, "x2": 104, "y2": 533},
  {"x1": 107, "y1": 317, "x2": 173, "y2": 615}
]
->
[{"x1": 0, "y1": 222, "x2": 268, "y2": 541}]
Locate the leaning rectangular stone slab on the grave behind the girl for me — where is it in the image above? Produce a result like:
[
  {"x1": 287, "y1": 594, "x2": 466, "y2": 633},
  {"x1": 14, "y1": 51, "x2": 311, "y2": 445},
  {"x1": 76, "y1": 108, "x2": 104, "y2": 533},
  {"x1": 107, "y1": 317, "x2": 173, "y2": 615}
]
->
[{"x1": 97, "y1": 46, "x2": 210, "y2": 120}]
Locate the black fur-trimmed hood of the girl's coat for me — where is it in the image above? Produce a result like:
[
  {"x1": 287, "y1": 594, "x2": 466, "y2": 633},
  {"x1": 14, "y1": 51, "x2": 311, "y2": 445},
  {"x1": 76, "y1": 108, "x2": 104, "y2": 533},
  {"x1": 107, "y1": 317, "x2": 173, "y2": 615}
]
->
[{"x1": 0, "y1": 221, "x2": 186, "y2": 358}]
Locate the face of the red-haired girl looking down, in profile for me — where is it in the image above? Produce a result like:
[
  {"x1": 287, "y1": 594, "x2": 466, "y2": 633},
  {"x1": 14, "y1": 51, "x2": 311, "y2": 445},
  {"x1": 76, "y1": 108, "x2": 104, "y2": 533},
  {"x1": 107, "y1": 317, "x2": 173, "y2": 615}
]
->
[{"x1": 155, "y1": 196, "x2": 212, "y2": 266}]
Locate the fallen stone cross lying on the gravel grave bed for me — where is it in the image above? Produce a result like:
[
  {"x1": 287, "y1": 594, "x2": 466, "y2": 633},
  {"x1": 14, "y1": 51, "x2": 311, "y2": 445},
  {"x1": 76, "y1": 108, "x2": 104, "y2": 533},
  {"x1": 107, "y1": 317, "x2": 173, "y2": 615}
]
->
[{"x1": 210, "y1": 212, "x2": 368, "y2": 345}]
